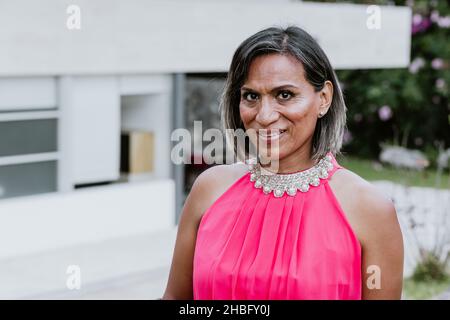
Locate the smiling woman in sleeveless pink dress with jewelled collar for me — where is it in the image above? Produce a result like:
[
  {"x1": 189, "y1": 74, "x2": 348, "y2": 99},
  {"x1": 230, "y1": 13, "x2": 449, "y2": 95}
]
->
[{"x1": 163, "y1": 26, "x2": 403, "y2": 300}]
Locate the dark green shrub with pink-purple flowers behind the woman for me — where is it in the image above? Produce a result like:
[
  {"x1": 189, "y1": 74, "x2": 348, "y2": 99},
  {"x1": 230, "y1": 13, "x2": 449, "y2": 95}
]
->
[{"x1": 314, "y1": 0, "x2": 450, "y2": 166}]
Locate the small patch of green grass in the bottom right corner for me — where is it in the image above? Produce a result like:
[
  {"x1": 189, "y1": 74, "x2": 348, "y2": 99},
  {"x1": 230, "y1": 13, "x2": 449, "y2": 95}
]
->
[{"x1": 403, "y1": 277, "x2": 450, "y2": 300}]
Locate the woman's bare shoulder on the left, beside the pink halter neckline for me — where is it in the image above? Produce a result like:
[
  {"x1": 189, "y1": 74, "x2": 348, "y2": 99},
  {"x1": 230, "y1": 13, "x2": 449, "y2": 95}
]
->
[{"x1": 188, "y1": 163, "x2": 248, "y2": 224}]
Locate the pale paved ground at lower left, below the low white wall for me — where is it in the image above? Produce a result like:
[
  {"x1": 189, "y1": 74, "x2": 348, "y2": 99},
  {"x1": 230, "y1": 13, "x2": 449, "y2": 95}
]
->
[{"x1": 0, "y1": 228, "x2": 176, "y2": 299}]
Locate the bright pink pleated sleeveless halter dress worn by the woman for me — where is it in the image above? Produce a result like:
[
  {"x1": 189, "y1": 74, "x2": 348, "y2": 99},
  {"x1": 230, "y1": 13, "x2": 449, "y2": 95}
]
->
[{"x1": 193, "y1": 153, "x2": 362, "y2": 300}]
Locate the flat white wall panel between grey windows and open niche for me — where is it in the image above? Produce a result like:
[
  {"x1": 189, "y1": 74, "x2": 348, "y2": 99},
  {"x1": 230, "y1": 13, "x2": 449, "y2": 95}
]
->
[{"x1": 60, "y1": 76, "x2": 120, "y2": 184}]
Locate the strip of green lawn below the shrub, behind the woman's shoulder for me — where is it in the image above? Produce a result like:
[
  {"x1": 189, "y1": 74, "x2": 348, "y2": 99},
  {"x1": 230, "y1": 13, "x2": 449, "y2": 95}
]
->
[{"x1": 337, "y1": 155, "x2": 450, "y2": 189}]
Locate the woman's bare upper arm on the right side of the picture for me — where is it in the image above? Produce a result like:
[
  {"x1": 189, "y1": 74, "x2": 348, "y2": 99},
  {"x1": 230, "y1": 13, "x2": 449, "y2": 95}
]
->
[{"x1": 358, "y1": 187, "x2": 403, "y2": 300}]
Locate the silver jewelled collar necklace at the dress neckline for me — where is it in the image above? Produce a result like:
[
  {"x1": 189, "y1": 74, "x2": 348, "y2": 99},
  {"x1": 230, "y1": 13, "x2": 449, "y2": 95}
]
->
[{"x1": 246, "y1": 155, "x2": 333, "y2": 198}]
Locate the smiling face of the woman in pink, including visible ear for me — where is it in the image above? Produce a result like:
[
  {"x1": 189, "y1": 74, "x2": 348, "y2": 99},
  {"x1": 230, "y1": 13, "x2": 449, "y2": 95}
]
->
[{"x1": 239, "y1": 54, "x2": 332, "y2": 165}]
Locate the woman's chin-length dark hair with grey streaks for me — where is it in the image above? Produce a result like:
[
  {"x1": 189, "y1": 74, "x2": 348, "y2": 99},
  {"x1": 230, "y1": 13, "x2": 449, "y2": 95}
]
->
[{"x1": 220, "y1": 26, "x2": 346, "y2": 160}]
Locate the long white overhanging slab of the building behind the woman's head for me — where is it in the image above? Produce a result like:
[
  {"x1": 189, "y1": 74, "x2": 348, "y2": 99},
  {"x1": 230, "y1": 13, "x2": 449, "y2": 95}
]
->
[{"x1": 0, "y1": 0, "x2": 411, "y2": 76}]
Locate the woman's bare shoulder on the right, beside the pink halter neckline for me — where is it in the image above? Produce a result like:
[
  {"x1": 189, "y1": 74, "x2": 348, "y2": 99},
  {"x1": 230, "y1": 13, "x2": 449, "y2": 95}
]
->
[{"x1": 330, "y1": 168, "x2": 398, "y2": 243}]
